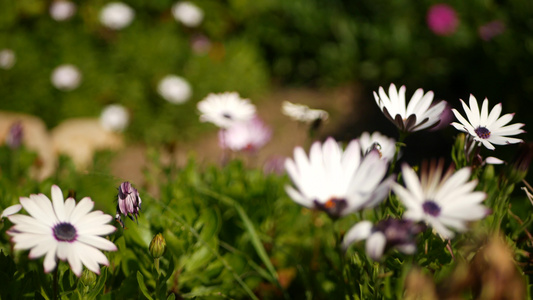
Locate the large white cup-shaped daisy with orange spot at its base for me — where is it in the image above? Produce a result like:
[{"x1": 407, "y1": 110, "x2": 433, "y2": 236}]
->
[{"x1": 285, "y1": 138, "x2": 393, "y2": 217}]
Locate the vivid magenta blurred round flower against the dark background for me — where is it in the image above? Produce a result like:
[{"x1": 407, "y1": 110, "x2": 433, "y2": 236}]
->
[{"x1": 427, "y1": 4, "x2": 459, "y2": 36}]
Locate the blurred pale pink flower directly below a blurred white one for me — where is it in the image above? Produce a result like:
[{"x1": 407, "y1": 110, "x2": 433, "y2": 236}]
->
[{"x1": 218, "y1": 116, "x2": 272, "y2": 151}]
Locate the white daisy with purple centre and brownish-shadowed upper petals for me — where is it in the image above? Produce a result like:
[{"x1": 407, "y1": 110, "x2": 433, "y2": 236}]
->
[{"x1": 392, "y1": 160, "x2": 489, "y2": 239}]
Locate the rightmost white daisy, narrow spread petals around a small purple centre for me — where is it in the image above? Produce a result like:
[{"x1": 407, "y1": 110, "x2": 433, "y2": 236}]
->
[{"x1": 452, "y1": 95, "x2": 524, "y2": 150}]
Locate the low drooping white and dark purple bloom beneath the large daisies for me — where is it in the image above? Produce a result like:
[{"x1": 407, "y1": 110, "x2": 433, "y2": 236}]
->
[{"x1": 342, "y1": 218, "x2": 425, "y2": 260}]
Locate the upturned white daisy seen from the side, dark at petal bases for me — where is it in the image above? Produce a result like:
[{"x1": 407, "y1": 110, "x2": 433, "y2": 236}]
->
[{"x1": 374, "y1": 83, "x2": 446, "y2": 132}]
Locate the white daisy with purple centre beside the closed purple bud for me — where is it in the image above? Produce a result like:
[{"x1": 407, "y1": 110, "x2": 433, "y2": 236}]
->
[{"x1": 7, "y1": 185, "x2": 117, "y2": 277}]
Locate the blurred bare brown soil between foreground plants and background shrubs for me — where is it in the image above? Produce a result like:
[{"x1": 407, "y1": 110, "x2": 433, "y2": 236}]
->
[{"x1": 111, "y1": 86, "x2": 360, "y2": 183}]
